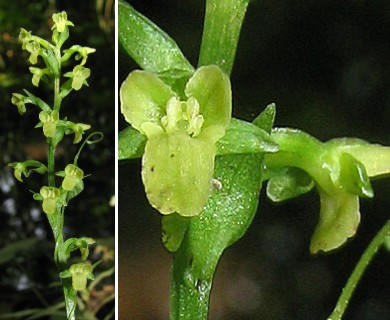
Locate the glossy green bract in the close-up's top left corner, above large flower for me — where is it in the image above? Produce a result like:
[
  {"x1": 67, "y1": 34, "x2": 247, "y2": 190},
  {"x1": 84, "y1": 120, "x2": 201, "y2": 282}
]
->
[{"x1": 118, "y1": 0, "x2": 194, "y2": 76}]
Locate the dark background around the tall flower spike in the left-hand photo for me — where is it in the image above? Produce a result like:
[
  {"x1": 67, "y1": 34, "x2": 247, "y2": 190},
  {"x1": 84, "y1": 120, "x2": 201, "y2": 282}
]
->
[{"x1": 0, "y1": 0, "x2": 115, "y2": 319}]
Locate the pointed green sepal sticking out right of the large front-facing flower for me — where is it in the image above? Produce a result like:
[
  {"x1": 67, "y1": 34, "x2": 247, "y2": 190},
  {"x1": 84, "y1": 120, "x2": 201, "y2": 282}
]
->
[{"x1": 217, "y1": 118, "x2": 278, "y2": 155}]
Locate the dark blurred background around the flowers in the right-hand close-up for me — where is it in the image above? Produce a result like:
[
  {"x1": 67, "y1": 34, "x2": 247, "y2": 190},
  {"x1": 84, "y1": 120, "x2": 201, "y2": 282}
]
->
[{"x1": 119, "y1": 0, "x2": 390, "y2": 320}]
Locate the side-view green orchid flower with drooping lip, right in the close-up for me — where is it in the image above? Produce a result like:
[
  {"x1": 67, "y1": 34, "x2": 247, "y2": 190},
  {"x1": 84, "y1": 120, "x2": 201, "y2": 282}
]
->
[{"x1": 265, "y1": 128, "x2": 390, "y2": 253}]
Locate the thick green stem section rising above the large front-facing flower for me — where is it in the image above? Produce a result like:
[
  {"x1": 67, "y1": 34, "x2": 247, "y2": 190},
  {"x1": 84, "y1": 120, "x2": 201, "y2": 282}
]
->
[{"x1": 198, "y1": 0, "x2": 249, "y2": 75}]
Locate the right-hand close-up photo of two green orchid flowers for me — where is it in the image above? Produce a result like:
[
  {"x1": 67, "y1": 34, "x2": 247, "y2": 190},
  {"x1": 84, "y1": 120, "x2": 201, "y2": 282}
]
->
[{"x1": 117, "y1": 0, "x2": 390, "y2": 320}]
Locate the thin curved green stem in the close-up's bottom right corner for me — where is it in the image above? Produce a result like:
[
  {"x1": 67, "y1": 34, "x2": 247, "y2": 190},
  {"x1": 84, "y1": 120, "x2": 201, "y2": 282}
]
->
[{"x1": 328, "y1": 219, "x2": 390, "y2": 320}]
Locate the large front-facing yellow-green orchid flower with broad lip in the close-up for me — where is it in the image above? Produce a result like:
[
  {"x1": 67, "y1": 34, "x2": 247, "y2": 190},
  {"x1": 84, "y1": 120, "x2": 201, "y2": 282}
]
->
[{"x1": 120, "y1": 66, "x2": 232, "y2": 216}]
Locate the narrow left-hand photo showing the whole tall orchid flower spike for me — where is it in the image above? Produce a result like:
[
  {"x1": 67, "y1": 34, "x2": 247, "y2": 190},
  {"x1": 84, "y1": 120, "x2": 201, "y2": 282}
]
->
[{"x1": 0, "y1": 0, "x2": 116, "y2": 320}]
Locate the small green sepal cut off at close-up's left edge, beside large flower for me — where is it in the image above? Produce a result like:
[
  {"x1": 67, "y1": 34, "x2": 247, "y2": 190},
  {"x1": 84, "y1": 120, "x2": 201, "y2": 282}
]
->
[{"x1": 118, "y1": 127, "x2": 146, "y2": 160}]
